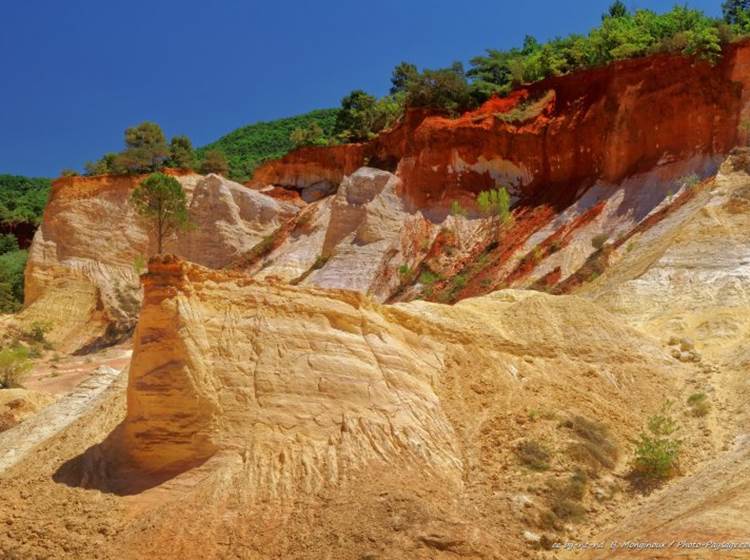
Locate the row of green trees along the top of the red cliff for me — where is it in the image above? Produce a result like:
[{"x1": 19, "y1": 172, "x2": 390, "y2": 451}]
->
[{"x1": 292, "y1": 0, "x2": 750, "y2": 146}]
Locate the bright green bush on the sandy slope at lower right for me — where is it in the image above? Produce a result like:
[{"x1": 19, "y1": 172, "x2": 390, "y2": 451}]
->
[{"x1": 633, "y1": 401, "x2": 681, "y2": 480}]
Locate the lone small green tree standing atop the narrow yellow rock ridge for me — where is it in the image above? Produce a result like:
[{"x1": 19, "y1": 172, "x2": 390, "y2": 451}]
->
[{"x1": 130, "y1": 173, "x2": 190, "y2": 254}]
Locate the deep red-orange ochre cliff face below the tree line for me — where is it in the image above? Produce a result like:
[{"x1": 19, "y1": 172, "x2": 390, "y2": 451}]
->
[{"x1": 249, "y1": 42, "x2": 750, "y2": 207}]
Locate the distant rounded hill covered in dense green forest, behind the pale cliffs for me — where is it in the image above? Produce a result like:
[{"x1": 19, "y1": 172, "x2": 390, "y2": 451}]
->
[{"x1": 197, "y1": 109, "x2": 339, "y2": 181}]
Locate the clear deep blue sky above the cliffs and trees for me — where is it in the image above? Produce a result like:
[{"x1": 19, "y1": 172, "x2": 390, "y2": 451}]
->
[{"x1": 0, "y1": 0, "x2": 721, "y2": 176}]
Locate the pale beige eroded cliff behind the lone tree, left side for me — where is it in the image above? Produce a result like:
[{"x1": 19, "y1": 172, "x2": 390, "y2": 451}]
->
[{"x1": 21, "y1": 174, "x2": 297, "y2": 349}]
